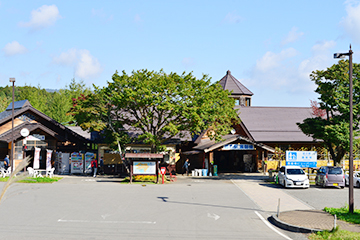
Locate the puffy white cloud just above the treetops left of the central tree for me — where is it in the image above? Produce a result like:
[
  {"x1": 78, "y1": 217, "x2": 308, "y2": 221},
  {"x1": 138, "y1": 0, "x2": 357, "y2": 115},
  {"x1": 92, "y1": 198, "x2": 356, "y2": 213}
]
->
[{"x1": 53, "y1": 48, "x2": 103, "y2": 79}]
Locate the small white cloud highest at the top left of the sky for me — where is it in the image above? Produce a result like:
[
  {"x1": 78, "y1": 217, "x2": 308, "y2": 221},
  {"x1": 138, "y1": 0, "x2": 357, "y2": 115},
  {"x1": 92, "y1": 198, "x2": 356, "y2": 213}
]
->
[{"x1": 19, "y1": 5, "x2": 61, "y2": 30}]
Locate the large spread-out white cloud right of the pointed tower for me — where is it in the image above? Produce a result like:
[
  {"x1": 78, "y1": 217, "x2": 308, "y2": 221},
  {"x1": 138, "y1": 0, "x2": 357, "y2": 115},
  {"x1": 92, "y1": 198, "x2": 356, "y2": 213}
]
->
[{"x1": 248, "y1": 41, "x2": 336, "y2": 94}]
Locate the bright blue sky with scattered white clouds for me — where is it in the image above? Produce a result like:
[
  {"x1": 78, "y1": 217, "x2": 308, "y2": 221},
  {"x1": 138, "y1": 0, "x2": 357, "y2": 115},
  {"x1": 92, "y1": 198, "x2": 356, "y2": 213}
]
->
[{"x1": 0, "y1": 0, "x2": 360, "y2": 107}]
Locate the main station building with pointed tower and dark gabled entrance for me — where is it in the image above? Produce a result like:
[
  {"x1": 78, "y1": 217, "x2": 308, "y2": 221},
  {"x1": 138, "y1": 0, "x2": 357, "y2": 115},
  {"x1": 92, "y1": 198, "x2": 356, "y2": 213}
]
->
[{"x1": 177, "y1": 71, "x2": 319, "y2": 172}]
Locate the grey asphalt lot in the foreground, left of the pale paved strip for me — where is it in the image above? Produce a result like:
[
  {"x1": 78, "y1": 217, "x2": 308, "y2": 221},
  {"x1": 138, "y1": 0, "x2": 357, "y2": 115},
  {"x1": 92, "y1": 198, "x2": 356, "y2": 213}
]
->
[{"x1": 0, "y1": 173, "x2": 300, "y2": 240}]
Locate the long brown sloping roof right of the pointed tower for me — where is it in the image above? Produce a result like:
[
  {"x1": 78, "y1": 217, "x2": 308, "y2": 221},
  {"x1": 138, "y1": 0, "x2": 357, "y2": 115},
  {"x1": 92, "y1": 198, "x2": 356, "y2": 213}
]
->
[{"x1": 235, "y1": 107, "x2": 314, "y2": 142}]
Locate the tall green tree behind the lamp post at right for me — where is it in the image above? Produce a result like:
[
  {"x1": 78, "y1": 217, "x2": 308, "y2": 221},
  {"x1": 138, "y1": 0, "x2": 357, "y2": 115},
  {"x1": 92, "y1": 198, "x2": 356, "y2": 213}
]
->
[{"x1": 298, "y1": 60, "x2": 360, "y2": 163}]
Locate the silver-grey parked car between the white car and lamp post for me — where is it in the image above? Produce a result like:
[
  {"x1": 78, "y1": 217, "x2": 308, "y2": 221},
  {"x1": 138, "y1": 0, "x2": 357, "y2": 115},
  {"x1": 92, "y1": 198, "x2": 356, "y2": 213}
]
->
[{"x1": 315, "y1": 166, "x2": 345, "y2": 188}]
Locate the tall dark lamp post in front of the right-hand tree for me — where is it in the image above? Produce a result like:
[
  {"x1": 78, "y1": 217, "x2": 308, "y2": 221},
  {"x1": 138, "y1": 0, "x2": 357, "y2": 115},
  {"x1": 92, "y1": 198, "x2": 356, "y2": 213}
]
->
[{"x1": 334, "y1": 45, "x2": 354, "y2": 213}]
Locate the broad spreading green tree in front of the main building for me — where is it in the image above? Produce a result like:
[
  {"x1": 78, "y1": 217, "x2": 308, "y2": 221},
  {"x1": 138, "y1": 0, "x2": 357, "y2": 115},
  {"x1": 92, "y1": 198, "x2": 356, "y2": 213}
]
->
[{"x1": 71, "y1": 70, "x2": 238, "y2": 152}]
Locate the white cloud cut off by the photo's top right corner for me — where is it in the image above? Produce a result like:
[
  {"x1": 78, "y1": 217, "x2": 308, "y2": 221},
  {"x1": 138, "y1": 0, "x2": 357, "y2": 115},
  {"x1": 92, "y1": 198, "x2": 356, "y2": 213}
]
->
[{"x1": 340, "y1": 1, "x2": 360, "y2": 43}]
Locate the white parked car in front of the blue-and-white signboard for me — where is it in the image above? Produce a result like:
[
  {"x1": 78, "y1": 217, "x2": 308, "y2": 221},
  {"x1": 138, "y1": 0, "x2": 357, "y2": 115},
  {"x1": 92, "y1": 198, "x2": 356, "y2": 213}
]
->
[{"x1": 278, "y1": 166, "x2": 310, "y2": 188}]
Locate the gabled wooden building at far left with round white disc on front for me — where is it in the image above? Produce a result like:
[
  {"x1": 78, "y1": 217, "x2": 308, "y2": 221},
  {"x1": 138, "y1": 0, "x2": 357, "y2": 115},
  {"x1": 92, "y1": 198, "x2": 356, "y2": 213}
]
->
[{"x1": 0, "y1": 100, "x2": 94, "y2": 169}]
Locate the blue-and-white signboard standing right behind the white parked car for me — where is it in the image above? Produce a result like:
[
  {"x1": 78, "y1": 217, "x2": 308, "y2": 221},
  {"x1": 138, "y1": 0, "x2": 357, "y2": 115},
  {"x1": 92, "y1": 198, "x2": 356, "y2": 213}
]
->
[{"x1": 286, "y1": 151, "x2": 317, "y2": 168}]
